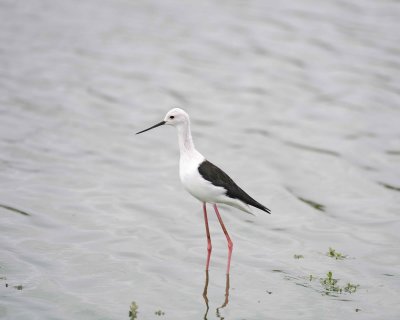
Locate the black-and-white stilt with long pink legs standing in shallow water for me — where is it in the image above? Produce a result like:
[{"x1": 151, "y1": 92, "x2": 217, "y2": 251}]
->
[{"x1": 136, "y1": 108, "x2": 271, "y2": 274}]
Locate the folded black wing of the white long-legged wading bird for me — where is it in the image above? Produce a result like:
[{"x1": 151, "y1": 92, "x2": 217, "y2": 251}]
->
[{"x1": 199, "y1": 160, "x2": 271, "y2": 213}]
